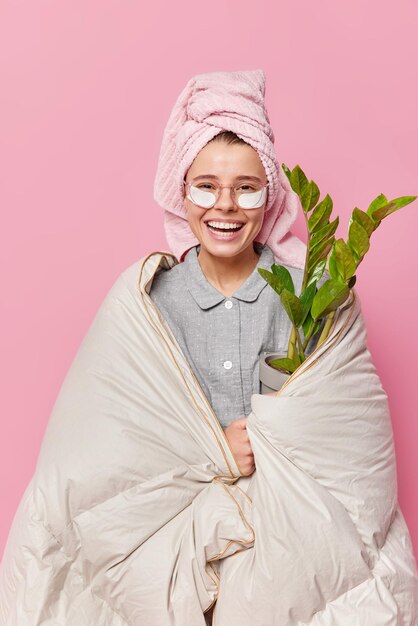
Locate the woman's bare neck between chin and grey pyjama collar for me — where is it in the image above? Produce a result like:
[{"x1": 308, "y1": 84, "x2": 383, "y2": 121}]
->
[{"x1": 198, "y1": 244, "x2": 260, "y2": 296}]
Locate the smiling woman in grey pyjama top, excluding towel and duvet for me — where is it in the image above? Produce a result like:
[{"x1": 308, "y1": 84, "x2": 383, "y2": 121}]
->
[{"x1": 150, "y1": 131, "x2": 323, "y2": 474}]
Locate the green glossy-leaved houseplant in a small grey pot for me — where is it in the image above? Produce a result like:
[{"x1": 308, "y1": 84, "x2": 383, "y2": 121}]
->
[{"x1": 258, "y1": 163, "x2": 417, "y2": 393}]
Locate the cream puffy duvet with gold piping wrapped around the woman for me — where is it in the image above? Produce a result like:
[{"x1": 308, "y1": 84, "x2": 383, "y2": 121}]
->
[{"x1": 0, "y1": 252, "x2": 418, "y2": 626}]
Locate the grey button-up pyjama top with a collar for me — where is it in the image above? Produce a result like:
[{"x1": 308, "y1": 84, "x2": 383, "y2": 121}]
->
[{"x1": 149, "y1": 242, "x2": 325, "y2": 428}]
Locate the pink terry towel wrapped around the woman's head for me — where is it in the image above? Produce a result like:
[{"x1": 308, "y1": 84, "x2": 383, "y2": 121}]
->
[{"x1": 154, "y1": 70, "x2": 306, "y2": 268}]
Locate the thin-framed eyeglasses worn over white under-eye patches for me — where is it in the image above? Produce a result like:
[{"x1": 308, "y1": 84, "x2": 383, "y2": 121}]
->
[{"x1": 183, "y1": 178, "x2": 268, "y2": 209}]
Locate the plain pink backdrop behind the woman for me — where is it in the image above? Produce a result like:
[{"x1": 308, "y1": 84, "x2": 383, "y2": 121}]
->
[{"x1": 0, "y1": 0, "x2": 418, "y2": 555}]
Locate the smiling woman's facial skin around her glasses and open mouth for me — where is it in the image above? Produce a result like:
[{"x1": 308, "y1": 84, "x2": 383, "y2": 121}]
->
[{"x1": 184, "y1": 141, "x2": 267, "y2": 257}]
